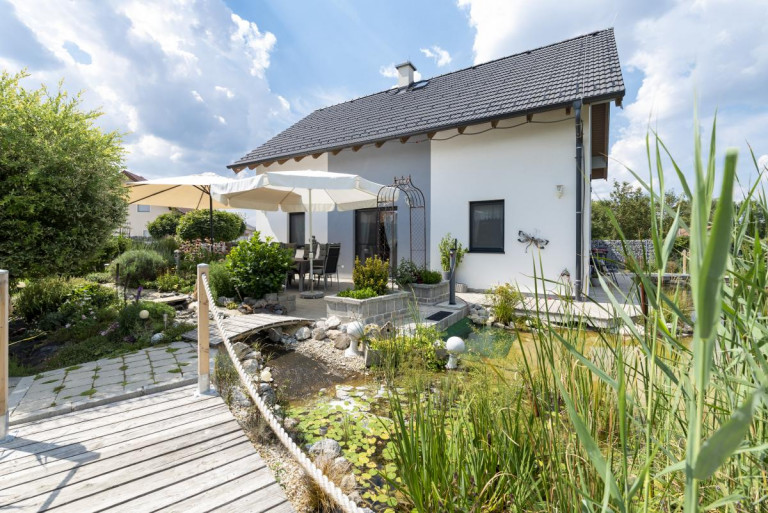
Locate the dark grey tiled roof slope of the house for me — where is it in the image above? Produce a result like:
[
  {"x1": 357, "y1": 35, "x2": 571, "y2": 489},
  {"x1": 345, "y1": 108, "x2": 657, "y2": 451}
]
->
[{"x1": 227, "y1": 29, "x2": 624, "y2": 171}]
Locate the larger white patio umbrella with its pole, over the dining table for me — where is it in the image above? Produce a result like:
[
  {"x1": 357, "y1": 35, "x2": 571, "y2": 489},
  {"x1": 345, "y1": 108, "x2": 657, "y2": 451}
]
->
[{"x1": 212, "y1": 170, "x2": 383, "y2": 297}]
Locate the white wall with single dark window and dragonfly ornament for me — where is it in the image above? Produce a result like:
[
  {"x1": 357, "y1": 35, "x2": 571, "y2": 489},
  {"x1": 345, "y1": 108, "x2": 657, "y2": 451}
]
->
[{"x1": 430, "y1": 109, "x2": 589, "y2": 291}]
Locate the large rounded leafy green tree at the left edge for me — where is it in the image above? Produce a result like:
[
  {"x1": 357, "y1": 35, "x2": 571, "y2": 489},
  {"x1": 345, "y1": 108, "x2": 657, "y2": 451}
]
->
[{"x1": 0, "y1": 71, "x2": 126, "y2": 276}]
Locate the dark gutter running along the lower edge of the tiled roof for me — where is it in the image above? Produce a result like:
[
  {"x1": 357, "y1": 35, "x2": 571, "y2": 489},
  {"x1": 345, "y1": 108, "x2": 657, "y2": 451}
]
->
[{"x1": 227, "y1": 91, "x2": 624, "y2": 170}]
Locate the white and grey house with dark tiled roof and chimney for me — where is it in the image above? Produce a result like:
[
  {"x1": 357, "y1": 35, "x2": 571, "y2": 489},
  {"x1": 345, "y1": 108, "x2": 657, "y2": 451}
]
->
[{"x1": 228, "y1": 29, "x2": 625, "y2": 295}]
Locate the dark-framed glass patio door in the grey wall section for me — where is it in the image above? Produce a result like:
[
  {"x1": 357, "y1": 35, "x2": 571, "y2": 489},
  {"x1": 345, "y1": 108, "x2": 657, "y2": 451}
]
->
[{"x1": 355, "y1": 208, "x2": 397, "y2": 265}]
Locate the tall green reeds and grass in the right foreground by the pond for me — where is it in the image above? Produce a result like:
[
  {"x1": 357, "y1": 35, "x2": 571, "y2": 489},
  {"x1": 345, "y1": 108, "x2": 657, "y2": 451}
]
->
[{"x1": 380, "y1": 118, "x2": 768, "y2": 513}]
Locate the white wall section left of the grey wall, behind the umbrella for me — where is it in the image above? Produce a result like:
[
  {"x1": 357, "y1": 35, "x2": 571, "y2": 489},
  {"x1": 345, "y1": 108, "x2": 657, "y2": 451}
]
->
[{"x1": 240, "y1": 153, "x2": 328, "y2": 242}]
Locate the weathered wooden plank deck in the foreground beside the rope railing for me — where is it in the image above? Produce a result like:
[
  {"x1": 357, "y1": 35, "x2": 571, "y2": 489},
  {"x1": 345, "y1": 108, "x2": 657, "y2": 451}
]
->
[{"x1": 0, "y1": 387, "x2": 294, "y2": 513}]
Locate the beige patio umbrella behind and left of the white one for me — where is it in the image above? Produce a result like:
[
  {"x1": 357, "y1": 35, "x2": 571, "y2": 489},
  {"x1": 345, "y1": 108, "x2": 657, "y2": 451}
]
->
[{"x1": 125, "y1": 173, "x2": 237, "y2": 242}]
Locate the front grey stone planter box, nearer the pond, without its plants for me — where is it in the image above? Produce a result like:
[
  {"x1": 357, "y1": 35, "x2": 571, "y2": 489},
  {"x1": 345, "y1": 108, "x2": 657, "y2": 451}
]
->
[{"x1": 323, "y1": 291, "x2": 413, "y2": 324}]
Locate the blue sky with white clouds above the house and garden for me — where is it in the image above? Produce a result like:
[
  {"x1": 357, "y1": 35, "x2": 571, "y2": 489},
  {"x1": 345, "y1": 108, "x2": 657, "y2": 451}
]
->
[{"x1": 0, "y1": 0, "x2": 768, "y2": 197}]
